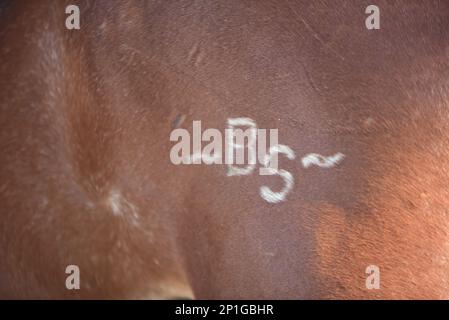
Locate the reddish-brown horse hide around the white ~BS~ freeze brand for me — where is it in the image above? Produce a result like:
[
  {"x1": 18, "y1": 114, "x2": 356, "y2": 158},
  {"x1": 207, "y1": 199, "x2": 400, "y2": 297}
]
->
[{"x1": 0, "y1": 0, "x2": 449, "y2": 299}]
